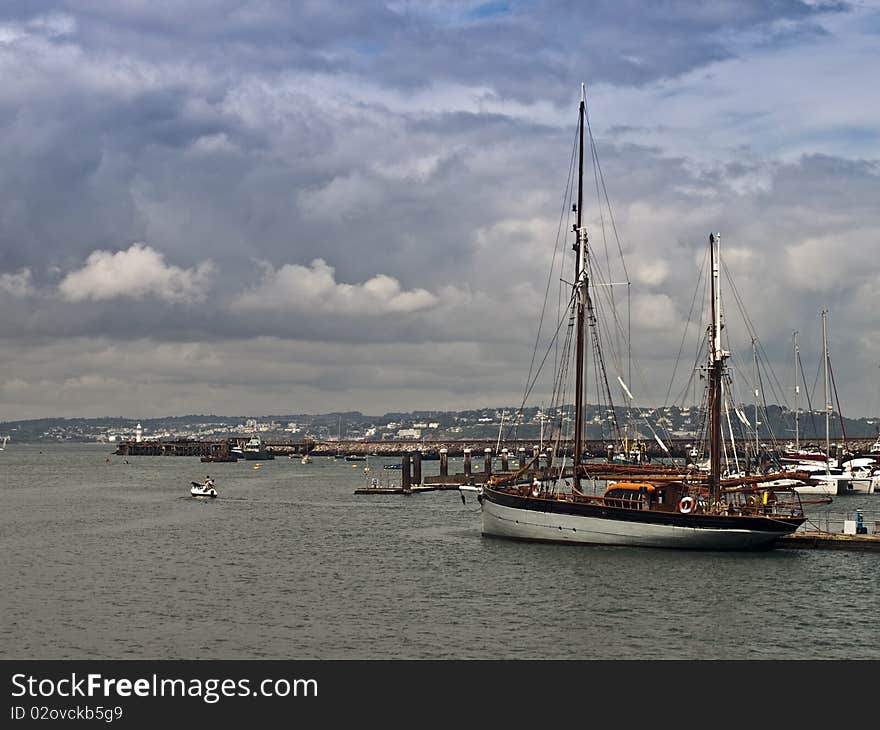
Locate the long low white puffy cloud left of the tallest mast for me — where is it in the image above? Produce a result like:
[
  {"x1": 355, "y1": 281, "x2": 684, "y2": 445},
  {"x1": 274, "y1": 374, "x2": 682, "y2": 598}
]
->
[{"x1": 233, "y1": 259, "x2": 438, "y2": 314}]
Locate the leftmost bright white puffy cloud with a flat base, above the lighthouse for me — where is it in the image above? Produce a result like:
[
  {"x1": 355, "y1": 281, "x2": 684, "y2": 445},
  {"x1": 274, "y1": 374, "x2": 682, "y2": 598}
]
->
[{"x1": 59, "y1": 243, "x2": 214, "y2": 302}]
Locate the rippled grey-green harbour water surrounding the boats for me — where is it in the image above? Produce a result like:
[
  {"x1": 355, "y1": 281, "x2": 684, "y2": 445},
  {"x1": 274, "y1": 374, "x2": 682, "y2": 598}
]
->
[{"x1": 0, "y1": 444, "x2": 880, "y2": 659}]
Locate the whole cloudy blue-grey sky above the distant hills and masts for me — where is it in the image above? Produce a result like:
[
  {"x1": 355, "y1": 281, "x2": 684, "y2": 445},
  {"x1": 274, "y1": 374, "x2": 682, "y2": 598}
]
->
[{"x1": 0, "y1": 0, "x2": 880, "y2": 421}]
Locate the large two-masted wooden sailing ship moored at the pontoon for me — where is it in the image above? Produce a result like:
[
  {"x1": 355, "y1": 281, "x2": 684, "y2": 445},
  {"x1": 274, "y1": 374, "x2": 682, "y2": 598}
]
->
[{"x1": 477, "y1": 86, "x2": 806, "y2": 550}]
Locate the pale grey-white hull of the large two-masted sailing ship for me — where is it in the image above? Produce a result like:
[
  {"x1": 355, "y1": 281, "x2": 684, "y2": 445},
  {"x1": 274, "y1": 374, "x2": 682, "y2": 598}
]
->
[{"x1": 482, "y1": 497, "x2": 791, "y2": 550}]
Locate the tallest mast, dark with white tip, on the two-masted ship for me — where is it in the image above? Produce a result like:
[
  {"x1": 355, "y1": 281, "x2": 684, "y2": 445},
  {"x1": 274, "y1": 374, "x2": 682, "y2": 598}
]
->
[{"x1": 573, "y1": 84, "x2": 587, "y2": 491}]
